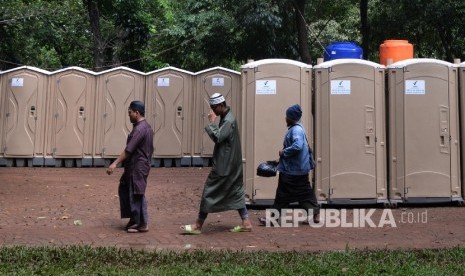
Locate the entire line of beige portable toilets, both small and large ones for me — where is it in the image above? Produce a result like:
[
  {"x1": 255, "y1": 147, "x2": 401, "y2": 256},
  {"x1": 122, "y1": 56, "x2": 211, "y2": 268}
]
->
[{"x1": 0, "y1": 59, "x2": 465, "y2": 207}]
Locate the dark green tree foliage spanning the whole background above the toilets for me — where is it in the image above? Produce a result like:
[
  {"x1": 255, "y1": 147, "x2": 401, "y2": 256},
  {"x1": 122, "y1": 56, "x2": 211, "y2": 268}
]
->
[{"x1": 0, "y1": 0, "x2": 465, "y2": 71}]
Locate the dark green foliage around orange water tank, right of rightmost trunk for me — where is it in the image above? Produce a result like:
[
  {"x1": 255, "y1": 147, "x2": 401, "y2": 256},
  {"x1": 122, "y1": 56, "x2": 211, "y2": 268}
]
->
[{"x1": 370, "y1": 0, "x2": 465, "y2": 62}]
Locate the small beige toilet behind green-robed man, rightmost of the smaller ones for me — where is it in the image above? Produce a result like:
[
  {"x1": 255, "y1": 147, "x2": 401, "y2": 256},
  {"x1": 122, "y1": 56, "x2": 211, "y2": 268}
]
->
[{"x1": 192, "y1": 67, "x2": 242, "y2": 167}]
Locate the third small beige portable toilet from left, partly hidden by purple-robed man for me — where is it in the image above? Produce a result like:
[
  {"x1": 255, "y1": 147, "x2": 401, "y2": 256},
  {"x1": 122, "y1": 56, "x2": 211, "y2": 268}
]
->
[{"x1": 93, "y1": 67, "x2": 147, "y2": 167}]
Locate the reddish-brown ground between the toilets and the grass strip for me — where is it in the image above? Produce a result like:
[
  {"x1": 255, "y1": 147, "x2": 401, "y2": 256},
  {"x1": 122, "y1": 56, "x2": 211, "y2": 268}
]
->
[{"x1": 0, "y1": 167, "x2": 465, "y2": 251}]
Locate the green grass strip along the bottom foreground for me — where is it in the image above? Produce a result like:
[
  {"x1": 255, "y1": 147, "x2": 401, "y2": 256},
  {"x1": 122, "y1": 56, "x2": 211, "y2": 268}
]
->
[{"x1": 0, "y1": 246, "x2": 465, "y2": 276}]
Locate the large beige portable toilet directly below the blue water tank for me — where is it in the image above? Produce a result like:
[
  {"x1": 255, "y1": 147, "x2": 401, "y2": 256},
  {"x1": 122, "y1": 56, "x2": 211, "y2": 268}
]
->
[{"x1": 313, "y1": 59, "x2": 389, "y2": 205}]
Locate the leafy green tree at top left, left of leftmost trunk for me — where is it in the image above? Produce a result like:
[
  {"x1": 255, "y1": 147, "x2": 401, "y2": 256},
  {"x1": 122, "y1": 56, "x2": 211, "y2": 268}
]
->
[{"x1": 0, "y1": 0, "x2": 90, "y2": 70}]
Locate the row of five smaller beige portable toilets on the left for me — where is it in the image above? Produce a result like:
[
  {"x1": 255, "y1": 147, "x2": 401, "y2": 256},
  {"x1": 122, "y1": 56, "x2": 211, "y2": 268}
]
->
[{"x1": 0, "y1": 67, "x2": 241, "y2": 167}]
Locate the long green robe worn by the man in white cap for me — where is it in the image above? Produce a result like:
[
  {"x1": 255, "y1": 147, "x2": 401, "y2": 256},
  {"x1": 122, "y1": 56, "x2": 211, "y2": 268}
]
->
[{"x1": 200, "y1": 108, "x2": 245, "y2": 213}]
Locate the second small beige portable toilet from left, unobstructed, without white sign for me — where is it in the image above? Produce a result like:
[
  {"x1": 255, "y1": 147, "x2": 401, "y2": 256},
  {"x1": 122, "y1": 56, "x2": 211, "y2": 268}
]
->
[{"x1": 45, "y1": 67, "x2": 96, "y2": 167}]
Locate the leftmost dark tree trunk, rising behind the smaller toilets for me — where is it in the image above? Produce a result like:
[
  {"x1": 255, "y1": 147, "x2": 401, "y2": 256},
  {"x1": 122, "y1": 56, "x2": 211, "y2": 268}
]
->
[{"x1": 83, "y1": 0, "x2": 105, "y2": 71}]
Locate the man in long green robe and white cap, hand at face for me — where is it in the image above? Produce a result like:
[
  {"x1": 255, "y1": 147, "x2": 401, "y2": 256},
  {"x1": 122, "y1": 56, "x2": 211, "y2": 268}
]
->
[{"x1": 181, "y1": 93, "x2": 252, "y2": 234}]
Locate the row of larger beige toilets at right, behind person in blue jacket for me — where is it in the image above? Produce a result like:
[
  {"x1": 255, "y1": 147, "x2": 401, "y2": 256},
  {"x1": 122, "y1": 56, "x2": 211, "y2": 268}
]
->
[{"x1": 241, "y1": 59, "x2": 465, "y2": 205}]
